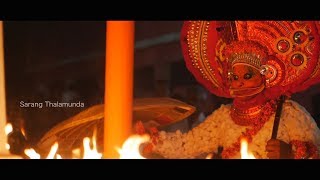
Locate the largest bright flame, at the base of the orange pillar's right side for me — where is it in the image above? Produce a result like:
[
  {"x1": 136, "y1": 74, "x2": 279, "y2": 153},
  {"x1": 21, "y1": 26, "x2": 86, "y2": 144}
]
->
[{"x1": 117, "y1": 134, "x2": 150, "y2": 159}]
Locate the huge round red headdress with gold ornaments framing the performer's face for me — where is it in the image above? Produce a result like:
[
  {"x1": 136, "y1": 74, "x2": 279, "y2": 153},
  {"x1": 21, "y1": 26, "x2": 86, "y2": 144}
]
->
[{"x1": 181, "y1": 21, "x2": 320, "y2": 98}]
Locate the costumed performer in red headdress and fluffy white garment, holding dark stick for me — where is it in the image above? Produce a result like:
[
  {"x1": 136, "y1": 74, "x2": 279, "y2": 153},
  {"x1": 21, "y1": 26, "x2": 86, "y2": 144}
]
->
[{"x1": 139, "y1": 21, "x2": 320, "y2": 159}]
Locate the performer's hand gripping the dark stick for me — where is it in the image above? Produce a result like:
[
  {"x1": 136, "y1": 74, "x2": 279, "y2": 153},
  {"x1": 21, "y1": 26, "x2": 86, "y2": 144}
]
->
[{"x1": 266, "y1": 139, "x2": 292, "y2": 159}]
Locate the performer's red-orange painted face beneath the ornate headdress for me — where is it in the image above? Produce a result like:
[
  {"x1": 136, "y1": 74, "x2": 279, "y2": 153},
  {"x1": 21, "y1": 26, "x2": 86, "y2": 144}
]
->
[{"x1": 230, "y1": 64, "x2": 264, "y2": 97}]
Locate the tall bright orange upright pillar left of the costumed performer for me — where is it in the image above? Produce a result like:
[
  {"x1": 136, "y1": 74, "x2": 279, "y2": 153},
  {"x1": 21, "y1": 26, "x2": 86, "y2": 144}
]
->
[{"x1": 103, "y1": 21, "x2": 134, "y2": 159}]
